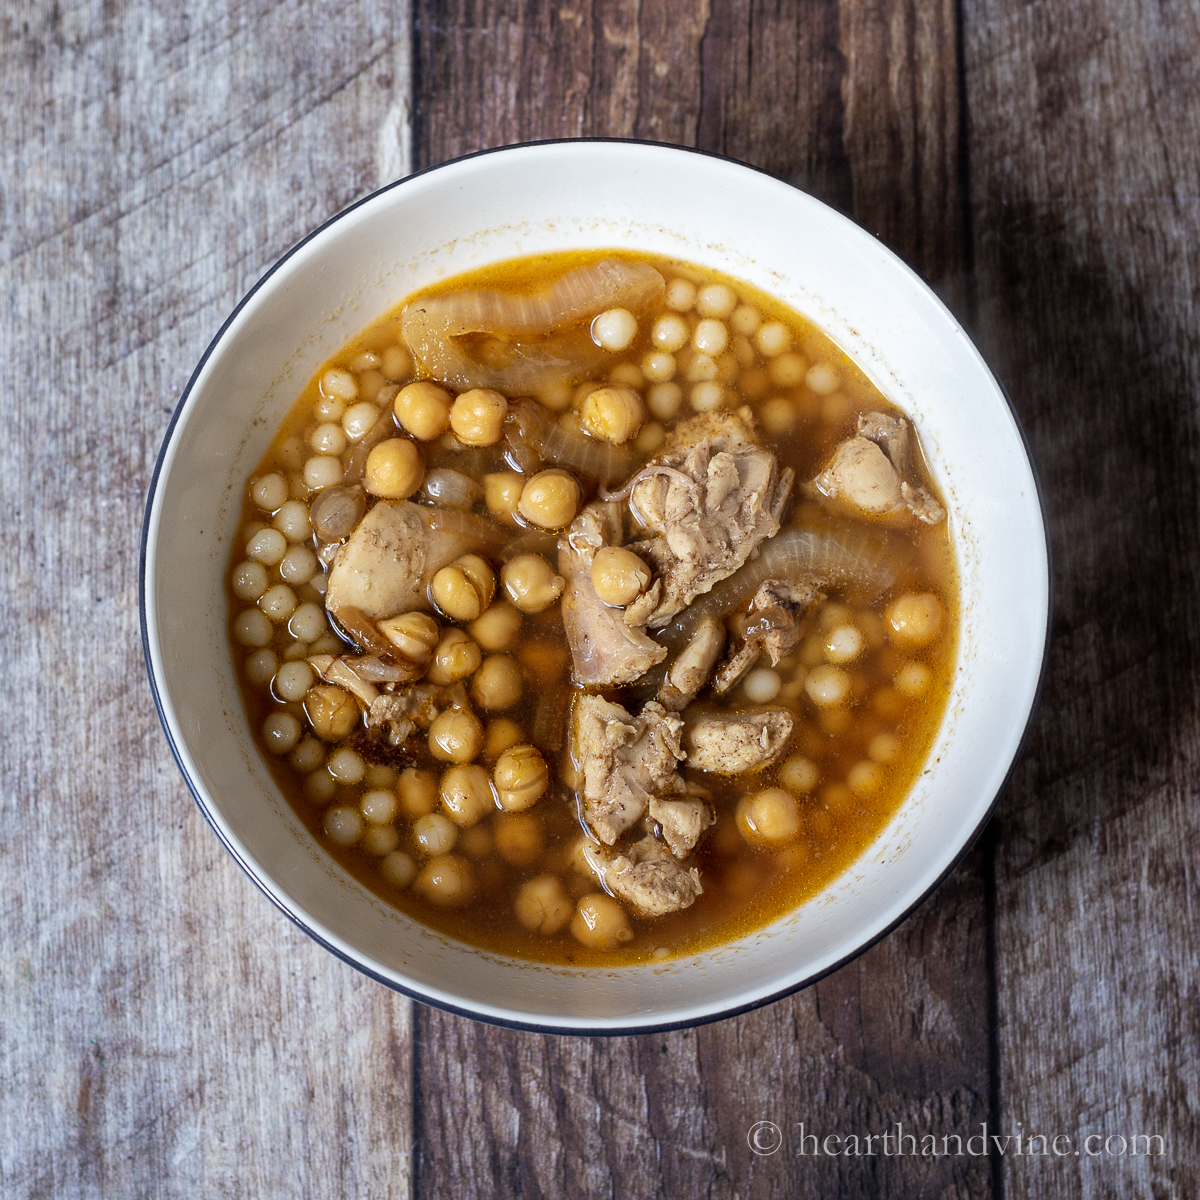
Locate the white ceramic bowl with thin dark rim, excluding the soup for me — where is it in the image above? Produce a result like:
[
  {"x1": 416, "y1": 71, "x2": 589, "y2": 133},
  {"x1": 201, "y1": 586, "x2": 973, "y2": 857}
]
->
[{"x1": 142, "y1": 142, "x2": 1049, "y2": 1033}]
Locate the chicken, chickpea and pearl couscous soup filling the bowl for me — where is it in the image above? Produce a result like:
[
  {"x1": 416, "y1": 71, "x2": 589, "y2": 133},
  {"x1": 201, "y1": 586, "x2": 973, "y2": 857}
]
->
[{"x1": 229, "y1": 253, "x2": 958, "y2": 965}]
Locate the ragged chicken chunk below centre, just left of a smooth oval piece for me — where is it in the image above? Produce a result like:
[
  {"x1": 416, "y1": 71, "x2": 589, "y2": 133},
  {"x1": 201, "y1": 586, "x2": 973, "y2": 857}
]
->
[{"x1": 570, "y1": 695, "x2": 684, "y2": 846}]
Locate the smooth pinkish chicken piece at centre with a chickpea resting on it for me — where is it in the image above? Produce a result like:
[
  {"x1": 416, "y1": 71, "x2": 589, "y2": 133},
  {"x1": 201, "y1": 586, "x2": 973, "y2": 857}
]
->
[{"x1": 558, "y1": 503, "x2": 667, "y2": 688}]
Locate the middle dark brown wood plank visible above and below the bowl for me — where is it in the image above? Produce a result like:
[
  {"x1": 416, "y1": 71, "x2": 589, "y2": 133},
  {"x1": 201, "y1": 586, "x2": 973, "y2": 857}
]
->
[{"x1": 414, "y1": 0, "x2": 991, "y2": 1196}]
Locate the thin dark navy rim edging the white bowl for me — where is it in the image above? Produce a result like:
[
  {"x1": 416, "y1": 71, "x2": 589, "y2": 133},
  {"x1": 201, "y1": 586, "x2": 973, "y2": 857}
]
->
[{"x1": 138, "y1": 137, "x2": 1055, "y2": 1037}]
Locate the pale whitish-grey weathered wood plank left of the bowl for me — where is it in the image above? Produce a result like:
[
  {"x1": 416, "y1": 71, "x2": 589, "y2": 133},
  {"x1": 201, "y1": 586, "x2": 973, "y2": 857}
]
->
[{"x1": 0, "y1": 0, "x2": 412, "y2": 1200}]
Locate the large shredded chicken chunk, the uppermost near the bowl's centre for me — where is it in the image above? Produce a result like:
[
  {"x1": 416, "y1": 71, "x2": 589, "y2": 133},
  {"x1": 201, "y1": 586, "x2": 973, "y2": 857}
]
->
[{"x1": 617, "y1": 413, "x2": 792, "y2": 629}]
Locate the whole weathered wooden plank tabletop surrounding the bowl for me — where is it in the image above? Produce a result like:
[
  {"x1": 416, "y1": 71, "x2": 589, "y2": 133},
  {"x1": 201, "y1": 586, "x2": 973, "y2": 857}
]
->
[{"x1": 0, "y1": 0, "x2": 1200, "y2": 1200}]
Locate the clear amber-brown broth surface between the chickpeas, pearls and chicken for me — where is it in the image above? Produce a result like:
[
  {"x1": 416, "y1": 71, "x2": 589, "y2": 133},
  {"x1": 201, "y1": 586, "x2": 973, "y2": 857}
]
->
[{"x1": 229, "y1": 252, "x2": 959, "y2": 965}]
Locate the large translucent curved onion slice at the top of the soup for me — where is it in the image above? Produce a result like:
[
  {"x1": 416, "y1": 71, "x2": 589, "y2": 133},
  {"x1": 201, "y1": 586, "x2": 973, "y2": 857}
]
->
[{"x1": 401, "y1": 258, "x2": 665, "y2": 395}]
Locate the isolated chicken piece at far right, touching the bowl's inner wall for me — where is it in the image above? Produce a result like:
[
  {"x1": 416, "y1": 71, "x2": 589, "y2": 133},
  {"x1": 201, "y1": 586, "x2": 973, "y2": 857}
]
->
[{"x1": 812, "y1": 413, "x2": 946, "y2": 524}]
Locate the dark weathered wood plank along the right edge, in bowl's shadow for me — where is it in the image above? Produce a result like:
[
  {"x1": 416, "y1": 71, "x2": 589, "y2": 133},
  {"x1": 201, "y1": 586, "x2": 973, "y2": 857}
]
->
[{"x1": 965, "y1": 0, "x2": 1200, "y2": 1198}]
